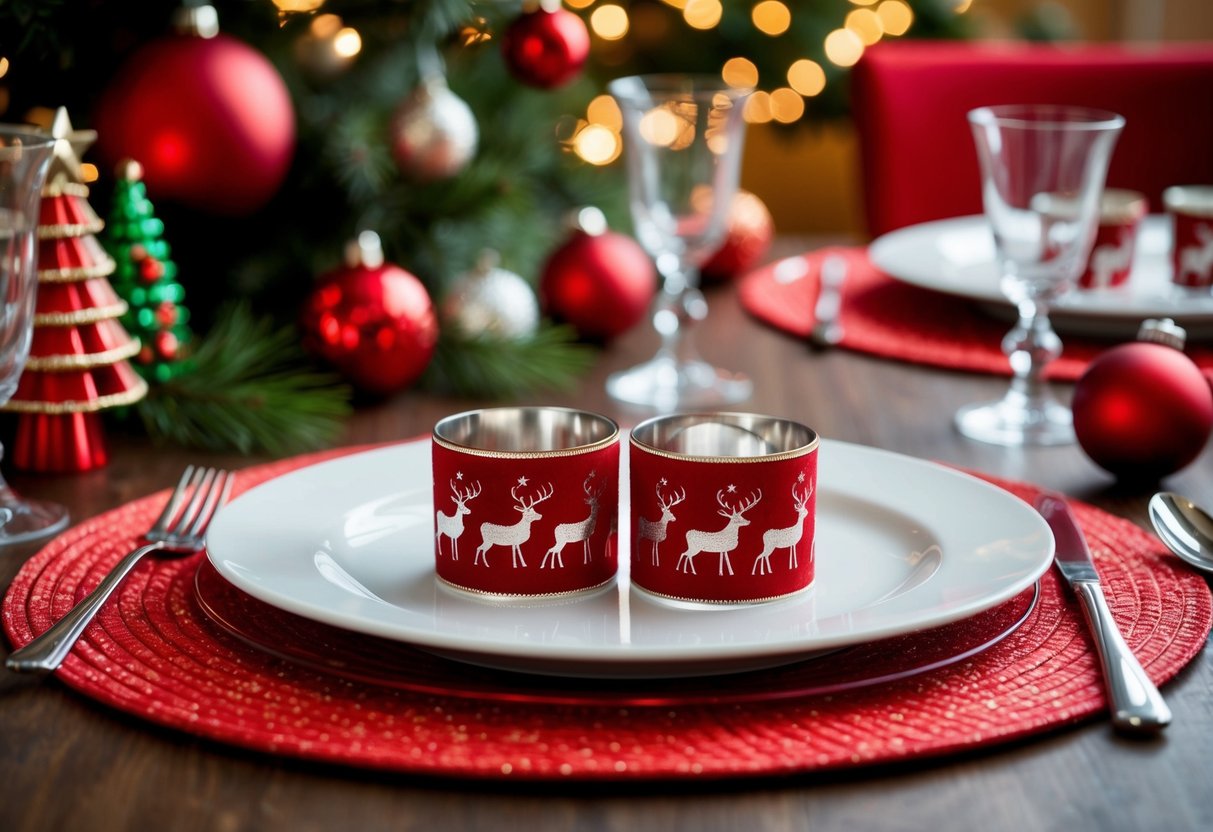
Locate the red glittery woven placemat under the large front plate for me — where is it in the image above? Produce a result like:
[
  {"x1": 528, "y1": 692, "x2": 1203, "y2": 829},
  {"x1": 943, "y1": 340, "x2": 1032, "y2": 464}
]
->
[{"x1": 2, "y1": 449, "x2": 1213, "y2": 780}]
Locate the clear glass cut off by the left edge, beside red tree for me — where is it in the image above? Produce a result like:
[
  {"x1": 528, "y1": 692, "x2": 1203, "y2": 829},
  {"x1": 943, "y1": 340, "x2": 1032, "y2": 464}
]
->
[{"x1": 0, "y1": 125, "x2": 68, "y2": 547}]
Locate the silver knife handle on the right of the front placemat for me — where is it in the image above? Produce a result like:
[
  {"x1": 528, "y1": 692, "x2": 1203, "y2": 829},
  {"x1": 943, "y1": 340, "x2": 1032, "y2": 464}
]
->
[{"x1": 1074, "y1": 581, "x2": 1171, "y2": 734}]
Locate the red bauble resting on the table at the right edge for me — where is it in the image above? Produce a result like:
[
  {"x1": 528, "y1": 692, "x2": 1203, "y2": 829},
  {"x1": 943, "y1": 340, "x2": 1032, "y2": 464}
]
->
[{"x1": 1072, "y1": 320, "x2": 1213, "y2": 479}]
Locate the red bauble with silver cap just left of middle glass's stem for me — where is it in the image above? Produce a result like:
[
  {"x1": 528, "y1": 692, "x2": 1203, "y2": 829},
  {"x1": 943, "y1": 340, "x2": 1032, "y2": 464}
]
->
[{"x1": 539, "y1": 209, "x2": 657, "y2": 340}]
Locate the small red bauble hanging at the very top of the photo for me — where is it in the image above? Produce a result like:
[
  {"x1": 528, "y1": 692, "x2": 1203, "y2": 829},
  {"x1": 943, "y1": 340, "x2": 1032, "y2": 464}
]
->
[{"x1": 501, "y1": 2, "x2": 590, "y2": 90}]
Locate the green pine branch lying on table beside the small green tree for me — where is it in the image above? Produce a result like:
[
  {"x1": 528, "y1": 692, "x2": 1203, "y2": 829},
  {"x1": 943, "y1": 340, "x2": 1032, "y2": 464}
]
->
[{"x1": 137, "y1": 304, "x2": 351, "y2": 456}]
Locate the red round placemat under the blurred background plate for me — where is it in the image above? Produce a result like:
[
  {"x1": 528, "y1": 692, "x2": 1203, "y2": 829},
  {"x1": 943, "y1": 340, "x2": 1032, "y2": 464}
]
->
[{"x1": 739, "y1": 247, "x2": 1213, "y2": 382}]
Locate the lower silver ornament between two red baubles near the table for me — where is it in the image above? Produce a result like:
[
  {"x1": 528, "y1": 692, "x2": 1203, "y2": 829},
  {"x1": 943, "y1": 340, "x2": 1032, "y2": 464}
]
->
[{"x1": 442, "y1": 252, "x2": 539, "y2": 341}]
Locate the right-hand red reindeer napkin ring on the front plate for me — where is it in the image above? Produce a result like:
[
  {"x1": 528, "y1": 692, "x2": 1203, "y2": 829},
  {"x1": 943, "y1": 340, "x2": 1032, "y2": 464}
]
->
[{"x1": 630, "y1": 414, "x2": 819, "y2": 604}]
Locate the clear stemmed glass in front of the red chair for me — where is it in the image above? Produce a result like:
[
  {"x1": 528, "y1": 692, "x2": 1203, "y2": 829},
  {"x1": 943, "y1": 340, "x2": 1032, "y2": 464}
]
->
[{"x1": 956, "y1": 104, "x2": 1124, "y2": 445}]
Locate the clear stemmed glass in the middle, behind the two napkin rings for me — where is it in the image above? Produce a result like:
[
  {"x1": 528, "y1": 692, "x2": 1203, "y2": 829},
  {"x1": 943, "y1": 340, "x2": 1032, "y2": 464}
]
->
[{"x1": 607, "y1": 75, "x2": 753, "y2": 410}]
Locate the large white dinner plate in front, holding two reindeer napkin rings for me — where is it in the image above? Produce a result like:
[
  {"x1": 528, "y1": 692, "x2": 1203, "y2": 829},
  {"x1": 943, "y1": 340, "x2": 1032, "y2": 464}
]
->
[{"x1": 207, "y1": 440, "x2": 1053, "y2": 678}]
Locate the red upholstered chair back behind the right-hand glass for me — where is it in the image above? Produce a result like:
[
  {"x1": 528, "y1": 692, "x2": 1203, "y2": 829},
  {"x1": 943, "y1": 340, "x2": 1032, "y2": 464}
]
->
[{"x1": 852, "y1": 41, "x2": 1213, "y2": 237}]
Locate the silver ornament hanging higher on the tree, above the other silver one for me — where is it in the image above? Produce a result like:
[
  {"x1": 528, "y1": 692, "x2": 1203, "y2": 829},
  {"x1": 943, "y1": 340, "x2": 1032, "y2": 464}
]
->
[{"x1": 392, "y1": 75, "x2": 480, "y2": 181}]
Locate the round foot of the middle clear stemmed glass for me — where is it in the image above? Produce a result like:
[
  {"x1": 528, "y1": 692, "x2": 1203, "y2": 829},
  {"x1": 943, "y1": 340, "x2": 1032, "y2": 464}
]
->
[{"x1": 607, "y1": 355, "x2": 753, "y2": 411}]
